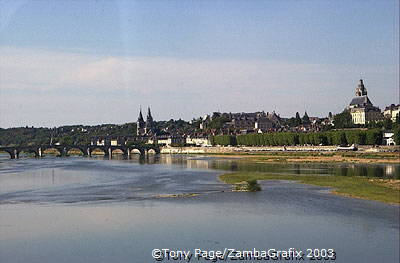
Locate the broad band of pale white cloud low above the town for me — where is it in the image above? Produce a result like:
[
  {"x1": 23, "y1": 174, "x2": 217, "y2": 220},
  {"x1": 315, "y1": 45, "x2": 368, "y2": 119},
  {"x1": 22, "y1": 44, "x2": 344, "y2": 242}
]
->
[{"x1": 0, "y1": 47, "x2": 398, "y2": 127}]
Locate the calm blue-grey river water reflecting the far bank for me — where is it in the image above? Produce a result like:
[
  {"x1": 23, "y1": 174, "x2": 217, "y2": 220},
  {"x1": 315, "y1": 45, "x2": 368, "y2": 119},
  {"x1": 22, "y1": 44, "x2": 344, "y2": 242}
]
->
[{"x1": 0, "y1": 155, "x2": 400, "y2": 263}]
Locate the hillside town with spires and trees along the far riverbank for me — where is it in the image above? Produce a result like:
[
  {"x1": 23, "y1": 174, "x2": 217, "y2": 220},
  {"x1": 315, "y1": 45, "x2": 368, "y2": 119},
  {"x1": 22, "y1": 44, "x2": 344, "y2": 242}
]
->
[{"x1": 0, "y1": 79, "x2": 400, "y2": 146}]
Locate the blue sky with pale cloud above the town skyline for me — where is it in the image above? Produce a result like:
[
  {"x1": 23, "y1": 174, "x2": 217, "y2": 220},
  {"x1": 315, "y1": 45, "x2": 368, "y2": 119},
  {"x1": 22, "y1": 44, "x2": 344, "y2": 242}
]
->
[{"x1": 0, "y1": 0, "x2": 399, "y2": 128}]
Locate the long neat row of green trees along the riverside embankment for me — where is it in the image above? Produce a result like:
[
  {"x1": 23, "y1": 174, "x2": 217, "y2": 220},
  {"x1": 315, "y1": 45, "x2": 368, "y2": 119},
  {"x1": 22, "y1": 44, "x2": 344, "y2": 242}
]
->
[{"x1": 211, "y1": 129, "x2": 382, "y2": 146}]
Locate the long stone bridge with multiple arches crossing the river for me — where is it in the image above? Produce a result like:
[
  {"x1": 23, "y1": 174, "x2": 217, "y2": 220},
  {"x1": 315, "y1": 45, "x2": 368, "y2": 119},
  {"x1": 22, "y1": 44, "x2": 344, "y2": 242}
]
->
[{"x1": 0, "y1": 144, "x2": 160, "y2": 159}]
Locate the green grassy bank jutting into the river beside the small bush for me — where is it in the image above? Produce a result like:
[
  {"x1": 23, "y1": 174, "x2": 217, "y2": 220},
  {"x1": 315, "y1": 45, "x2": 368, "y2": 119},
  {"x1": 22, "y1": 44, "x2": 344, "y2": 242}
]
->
[{"x1": 219, "y1": 172, "x2": 400, "y2": 204}]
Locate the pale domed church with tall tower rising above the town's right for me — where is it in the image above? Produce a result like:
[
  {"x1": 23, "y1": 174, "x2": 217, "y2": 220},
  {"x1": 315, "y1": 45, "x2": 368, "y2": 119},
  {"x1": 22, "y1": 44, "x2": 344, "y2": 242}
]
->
[{"x1": 348, "y1": 79, "x2": 382, "y2": 124}]
